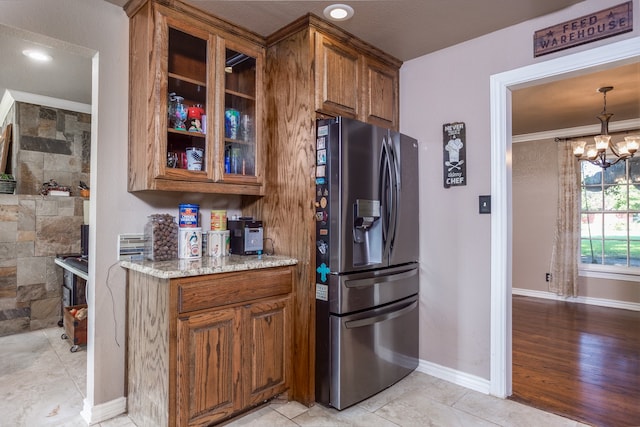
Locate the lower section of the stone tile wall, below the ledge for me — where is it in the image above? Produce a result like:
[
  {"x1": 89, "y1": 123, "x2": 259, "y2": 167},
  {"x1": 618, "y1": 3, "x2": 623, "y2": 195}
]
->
[{"x1": 0, "y1": 194, "x2": 84, "y2": 336}]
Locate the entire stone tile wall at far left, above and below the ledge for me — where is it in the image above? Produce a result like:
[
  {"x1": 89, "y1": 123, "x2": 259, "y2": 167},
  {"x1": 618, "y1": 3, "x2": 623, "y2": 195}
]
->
[{"x1": 0, "y1": 102, "x2": 91, "y2": 336}]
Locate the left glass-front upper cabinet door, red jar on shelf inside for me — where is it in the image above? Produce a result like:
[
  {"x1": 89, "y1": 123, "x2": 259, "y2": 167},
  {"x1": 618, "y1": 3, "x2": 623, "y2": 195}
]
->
[{"x1": 159, "y1": 23, "x2": 215, "y2": 180}]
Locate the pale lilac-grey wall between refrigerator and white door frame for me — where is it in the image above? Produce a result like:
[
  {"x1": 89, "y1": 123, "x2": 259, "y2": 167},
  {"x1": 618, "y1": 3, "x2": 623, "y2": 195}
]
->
[{"x1": 400, "y1": 0, "x2": 640, "y2": 379}]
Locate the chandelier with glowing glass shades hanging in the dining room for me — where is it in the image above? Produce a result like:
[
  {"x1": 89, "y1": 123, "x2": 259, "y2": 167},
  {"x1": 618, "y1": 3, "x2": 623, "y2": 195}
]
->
[{"x1": 573, "y1": 86, "x2": 640, "y2": 169}]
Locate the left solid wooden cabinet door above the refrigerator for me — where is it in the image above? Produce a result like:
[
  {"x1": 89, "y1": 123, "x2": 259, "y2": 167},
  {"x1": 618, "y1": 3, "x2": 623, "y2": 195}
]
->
[{"x1": 315, "y1": 33, "x2": 361, "y2": 118}]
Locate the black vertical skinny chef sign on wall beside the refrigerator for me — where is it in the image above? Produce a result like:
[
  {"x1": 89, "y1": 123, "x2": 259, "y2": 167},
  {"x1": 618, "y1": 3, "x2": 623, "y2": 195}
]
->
[{"x1": 442, "y1": 122, "x2": 467, "y2": 188}]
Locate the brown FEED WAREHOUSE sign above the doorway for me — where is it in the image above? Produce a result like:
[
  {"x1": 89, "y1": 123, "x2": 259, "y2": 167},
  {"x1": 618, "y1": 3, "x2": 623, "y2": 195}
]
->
[{"x1": 533, "y1": 1, "x2": 633, "y2": 57}]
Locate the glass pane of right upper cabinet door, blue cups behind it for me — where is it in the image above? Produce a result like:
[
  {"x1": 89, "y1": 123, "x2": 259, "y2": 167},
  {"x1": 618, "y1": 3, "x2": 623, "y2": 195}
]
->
[{"x1": 224, "y1": 48, "x2": 256, "y2": 176}]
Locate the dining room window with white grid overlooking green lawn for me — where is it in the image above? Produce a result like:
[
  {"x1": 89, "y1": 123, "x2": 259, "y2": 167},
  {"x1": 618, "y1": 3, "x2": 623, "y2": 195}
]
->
[{"x1": 580, "y1": 157, "x2": 640, "y2": 271}]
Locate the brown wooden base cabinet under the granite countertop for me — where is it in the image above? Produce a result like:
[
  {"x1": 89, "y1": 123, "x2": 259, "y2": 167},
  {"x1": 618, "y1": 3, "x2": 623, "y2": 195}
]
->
[{"x1": 128, "y1": 267, "x2": 293, "y2": 426}]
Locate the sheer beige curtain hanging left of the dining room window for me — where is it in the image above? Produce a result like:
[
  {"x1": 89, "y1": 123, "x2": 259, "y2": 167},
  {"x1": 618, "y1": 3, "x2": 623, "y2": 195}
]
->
[{"x1": 549, "y1": 141, "x2": 580, "y2": 297}]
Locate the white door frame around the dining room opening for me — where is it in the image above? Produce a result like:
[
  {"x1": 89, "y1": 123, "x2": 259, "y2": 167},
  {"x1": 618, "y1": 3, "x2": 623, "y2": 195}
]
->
[{"x1": 490, "y1": 37, "x2": 640, "y2": 398}]
